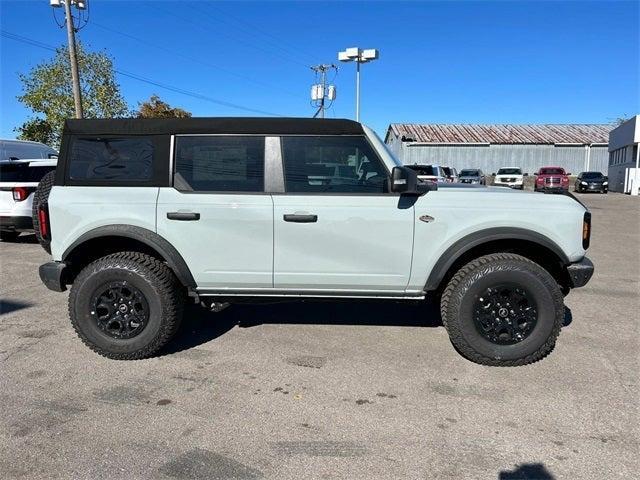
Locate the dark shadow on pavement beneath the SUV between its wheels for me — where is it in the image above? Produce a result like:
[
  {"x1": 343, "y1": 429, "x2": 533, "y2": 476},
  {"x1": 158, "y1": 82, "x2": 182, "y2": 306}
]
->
[{"x1": 160, "y1": 300, "x2": 442, "y2": 355}]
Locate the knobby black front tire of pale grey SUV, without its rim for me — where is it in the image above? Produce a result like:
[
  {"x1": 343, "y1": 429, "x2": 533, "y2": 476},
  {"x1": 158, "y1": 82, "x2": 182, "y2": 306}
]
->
[{"x1": 440, "y1": 253, "x2": 564, "y2": 367}]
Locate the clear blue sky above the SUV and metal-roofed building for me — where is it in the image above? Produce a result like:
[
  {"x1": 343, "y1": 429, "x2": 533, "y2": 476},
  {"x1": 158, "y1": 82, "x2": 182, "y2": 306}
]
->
[{"x1": 0, "y1": 0, "x2": 640, "y2": 138}]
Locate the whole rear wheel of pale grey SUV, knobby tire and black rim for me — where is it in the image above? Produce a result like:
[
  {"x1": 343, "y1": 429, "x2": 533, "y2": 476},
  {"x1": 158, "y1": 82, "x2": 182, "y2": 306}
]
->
[{"x1": 69, "y1": 252, "x2": 184, "y2": 360}]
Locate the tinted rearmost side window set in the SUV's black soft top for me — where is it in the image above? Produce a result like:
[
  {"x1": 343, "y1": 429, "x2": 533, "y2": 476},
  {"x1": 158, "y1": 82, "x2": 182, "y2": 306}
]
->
[{"x1": 68, "y1": 137, "x2": 154, "y2": 182}]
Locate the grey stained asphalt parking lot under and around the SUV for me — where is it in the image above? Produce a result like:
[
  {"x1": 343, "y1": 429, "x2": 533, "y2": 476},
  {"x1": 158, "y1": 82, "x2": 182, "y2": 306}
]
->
[{"x1": 0, "y1": 194, "x2": 640, "y2": 480}]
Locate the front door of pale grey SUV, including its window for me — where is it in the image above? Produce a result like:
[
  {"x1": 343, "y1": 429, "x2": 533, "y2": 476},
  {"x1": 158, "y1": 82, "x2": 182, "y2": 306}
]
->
[{"x1": 273, "y1": 136, "x2": 414, "y2": 294}]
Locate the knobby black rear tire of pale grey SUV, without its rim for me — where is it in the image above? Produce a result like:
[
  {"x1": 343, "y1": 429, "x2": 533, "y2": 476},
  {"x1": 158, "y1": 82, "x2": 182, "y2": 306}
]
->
[{"x1": 69, "y1": 252, "x2": 184, "y2": 360}]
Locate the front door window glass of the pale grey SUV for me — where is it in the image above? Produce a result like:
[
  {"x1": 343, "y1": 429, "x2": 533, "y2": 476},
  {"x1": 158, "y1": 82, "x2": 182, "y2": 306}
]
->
[{"x1": 282, "y1": 136, "x2": 389, "y2": 193}]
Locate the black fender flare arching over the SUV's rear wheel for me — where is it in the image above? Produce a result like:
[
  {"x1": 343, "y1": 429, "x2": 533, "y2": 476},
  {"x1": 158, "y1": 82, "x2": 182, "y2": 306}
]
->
[{"x1": 62, "y1": 224, "x2": 196, "y2": 288}]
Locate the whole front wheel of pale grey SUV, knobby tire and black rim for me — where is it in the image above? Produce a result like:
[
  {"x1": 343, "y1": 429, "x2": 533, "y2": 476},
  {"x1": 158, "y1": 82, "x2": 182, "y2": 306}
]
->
[{"x1": 440, "y1": 253, "x2": 564, "y2": 366}]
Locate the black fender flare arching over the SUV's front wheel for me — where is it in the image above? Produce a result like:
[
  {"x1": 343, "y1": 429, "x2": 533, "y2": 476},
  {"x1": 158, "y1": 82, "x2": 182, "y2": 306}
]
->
[{"x1": 425, "y1": 227, "x2": 571, "y2": 291}]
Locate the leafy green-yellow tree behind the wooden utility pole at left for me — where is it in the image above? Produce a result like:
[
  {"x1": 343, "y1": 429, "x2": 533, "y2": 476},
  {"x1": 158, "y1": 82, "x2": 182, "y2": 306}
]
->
[{"x1": 16, "y1": 43, "x2": 129, "y2": 146}]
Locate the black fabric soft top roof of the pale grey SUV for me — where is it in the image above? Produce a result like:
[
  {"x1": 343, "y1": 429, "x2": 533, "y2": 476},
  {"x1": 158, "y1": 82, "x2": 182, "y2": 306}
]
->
[{"x1": 64, "y1": 117, "x2": 363, "y2": 135}]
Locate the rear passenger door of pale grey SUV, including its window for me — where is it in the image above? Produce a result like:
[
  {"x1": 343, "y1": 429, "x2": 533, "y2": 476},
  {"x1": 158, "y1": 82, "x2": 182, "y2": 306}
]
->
[{"x1": 157, "y1": 135, "x2": 273, "y2": 291}]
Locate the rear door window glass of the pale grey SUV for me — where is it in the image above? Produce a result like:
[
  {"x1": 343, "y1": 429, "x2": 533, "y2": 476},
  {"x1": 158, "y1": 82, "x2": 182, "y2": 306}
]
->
[{"x1": 175, "y1": 136, "x2": 264, "y2": 192}]
